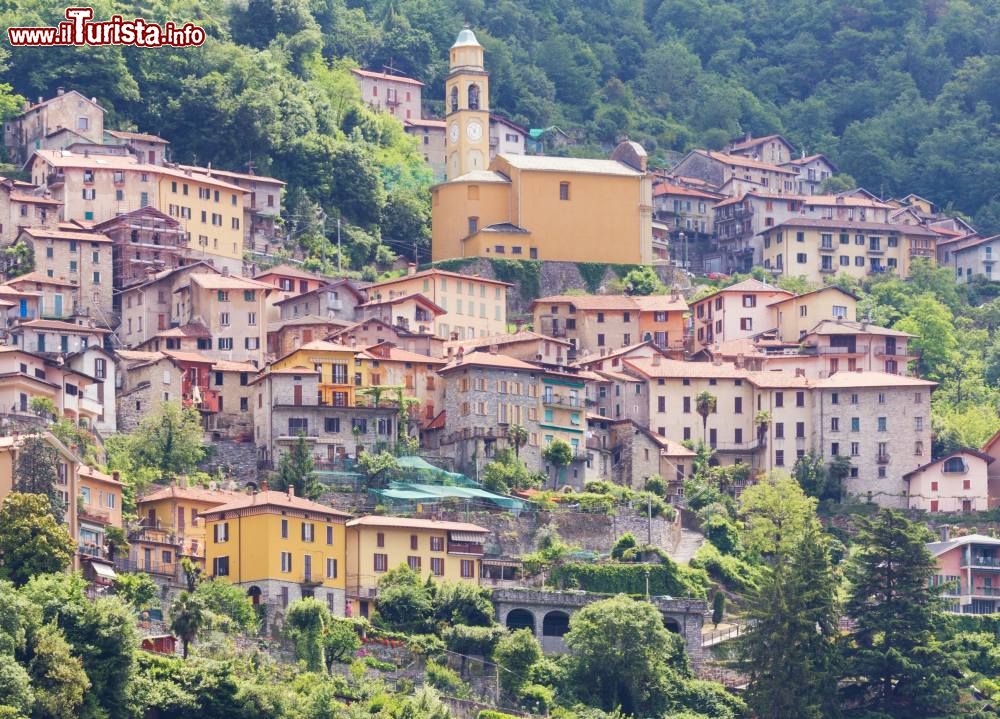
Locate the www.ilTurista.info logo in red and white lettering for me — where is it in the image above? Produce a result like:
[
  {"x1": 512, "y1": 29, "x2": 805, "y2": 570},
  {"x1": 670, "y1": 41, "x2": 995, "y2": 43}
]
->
[{"x1": 7, "y1": 7, "x2": 205, "y2": 47}]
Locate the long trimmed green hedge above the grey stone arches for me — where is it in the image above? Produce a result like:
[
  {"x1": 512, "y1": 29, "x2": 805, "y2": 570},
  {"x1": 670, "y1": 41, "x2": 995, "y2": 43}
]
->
[{"x1": 549, "y1": 560, "x2": 708, "y2": 599}]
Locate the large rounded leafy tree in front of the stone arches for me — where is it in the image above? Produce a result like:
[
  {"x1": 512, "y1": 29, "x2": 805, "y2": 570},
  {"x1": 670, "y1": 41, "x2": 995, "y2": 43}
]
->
[{"x1": 564, "y1": 595, "x2": 686, "y2": 716}]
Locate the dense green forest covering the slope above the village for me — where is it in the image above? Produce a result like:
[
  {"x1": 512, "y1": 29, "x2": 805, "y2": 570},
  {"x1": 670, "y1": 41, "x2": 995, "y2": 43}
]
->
[{"x1": 0, "y1": 0, "x2": 1000, "y2": 269}]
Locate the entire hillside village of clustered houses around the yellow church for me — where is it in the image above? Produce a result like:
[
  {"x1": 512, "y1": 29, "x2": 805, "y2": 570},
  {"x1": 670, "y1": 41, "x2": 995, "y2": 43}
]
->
[{"x1": 0, "y1": 18, "x2": 1000, "y2": 719}]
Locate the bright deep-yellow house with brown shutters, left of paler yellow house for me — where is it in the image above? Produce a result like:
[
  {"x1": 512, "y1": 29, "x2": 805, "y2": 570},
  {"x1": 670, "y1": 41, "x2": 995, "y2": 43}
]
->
[{"x1": 203, "y1": 484, "x2": 350, "y2": 621}]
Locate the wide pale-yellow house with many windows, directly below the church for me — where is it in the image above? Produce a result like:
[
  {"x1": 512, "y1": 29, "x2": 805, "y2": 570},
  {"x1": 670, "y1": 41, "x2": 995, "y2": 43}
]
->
[{"x1": 365, "y1": 269, "x2": 511, "y2": 340}]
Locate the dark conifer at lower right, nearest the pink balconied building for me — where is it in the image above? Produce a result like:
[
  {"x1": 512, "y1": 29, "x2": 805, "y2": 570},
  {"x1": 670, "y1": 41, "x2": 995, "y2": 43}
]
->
[{"x1": 844, "y1": 509, "x2": 958, "y2": 717}]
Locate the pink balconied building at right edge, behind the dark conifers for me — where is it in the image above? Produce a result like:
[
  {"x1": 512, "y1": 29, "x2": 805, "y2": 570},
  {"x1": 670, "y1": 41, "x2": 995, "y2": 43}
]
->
[{"x1": 927, "y1": 534, "x2": 1000, "y2": 614}]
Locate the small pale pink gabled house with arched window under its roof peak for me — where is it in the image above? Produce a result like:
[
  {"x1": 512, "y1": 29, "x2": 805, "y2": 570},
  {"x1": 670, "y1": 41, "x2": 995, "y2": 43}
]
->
[{"x1": 903, "y1": 448, "x2": 993, "y2": 512}]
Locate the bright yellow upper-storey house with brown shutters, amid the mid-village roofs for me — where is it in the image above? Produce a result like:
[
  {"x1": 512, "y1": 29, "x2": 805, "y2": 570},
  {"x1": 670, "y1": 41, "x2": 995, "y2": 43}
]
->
[{"x1": 270, "y1": 340, "x2": 368, "y2": 407}]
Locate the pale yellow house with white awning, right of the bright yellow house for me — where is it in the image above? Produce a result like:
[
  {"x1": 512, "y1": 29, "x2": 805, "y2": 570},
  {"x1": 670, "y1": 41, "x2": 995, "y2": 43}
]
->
[{"x1": 347, "y1": 515, "x2": 489, "y2": 617}]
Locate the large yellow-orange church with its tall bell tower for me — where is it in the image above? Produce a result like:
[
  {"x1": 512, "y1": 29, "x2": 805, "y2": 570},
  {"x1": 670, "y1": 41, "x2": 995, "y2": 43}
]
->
[{"x1": 431, "y1": 28, "x2": 653, "y2": 263}]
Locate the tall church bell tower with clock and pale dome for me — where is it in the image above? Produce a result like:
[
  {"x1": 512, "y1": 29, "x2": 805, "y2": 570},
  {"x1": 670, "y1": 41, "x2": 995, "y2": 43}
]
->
[{"x1": 444, "y1": 25, "x2": 490, "y2": 180}]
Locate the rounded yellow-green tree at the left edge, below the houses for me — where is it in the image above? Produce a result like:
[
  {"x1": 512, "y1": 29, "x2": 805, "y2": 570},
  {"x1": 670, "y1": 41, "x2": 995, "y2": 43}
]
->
[{"x1": 0, "y1": 492, "x2": 76, "y2": 586}]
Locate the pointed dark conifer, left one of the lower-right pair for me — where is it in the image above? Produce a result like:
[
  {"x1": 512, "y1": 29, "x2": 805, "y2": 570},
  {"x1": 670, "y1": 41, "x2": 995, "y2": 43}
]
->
[{"x1": 738, "y1": 525, "x2": 839, "y2": 719}]
